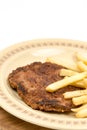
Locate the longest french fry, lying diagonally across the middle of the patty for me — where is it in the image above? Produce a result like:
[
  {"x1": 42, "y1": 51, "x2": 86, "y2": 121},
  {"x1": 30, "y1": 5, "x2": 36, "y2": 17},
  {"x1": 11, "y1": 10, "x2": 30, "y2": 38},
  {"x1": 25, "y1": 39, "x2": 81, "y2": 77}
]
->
[{"x1": 46, "y1": 72, "x2": 87, "y2": 92}]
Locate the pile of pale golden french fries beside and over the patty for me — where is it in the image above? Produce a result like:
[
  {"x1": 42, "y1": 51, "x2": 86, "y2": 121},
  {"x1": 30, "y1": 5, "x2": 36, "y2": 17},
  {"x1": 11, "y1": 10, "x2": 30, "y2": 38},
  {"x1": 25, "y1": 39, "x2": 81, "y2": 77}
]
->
[{"x1": 46, "y1": 52, "x2": 87, "y2": 118}]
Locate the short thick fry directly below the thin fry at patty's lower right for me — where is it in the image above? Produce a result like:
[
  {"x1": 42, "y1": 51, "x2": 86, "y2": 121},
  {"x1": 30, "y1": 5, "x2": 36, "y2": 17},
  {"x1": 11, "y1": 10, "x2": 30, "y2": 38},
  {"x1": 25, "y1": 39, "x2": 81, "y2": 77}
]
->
[{"x1": 72, "y1": 95, "x2": 87, "y2": 106}]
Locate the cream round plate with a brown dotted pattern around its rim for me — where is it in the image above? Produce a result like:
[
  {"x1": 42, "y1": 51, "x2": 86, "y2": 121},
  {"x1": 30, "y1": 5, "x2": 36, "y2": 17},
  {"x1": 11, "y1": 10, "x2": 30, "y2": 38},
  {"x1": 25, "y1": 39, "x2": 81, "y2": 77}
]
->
[{"x1": 0, "y1": 39, "x2": 87, "y2": 130}]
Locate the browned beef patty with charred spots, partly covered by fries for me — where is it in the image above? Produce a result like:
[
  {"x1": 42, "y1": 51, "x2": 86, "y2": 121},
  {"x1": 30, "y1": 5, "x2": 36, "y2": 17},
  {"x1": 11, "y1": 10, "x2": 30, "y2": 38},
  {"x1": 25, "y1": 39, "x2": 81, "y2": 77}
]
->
[{"x1": 8, "y1": 62, "x2": 78, "y2": 112}]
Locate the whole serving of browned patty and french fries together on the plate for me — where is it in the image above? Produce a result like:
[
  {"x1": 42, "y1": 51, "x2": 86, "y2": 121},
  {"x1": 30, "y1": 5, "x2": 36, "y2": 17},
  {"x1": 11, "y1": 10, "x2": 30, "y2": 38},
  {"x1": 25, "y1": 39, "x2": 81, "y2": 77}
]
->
[{"x1": 8, "y1": 52, "x2": 87, "y2": 118}]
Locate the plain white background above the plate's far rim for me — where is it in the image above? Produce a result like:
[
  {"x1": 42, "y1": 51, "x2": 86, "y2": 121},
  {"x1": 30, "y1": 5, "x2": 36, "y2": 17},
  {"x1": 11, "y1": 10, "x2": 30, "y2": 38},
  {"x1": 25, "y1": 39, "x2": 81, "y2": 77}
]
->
[{"x1": 0, "y1": 0, "x2": 87, "y2": 50}]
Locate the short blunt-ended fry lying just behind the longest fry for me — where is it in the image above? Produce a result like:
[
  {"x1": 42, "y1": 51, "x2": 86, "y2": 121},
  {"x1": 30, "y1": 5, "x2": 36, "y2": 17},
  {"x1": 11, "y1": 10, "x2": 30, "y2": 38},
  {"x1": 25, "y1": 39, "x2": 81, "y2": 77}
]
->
[{"x1": 60, "y1": 69, "x2": 78, "y2": 76}]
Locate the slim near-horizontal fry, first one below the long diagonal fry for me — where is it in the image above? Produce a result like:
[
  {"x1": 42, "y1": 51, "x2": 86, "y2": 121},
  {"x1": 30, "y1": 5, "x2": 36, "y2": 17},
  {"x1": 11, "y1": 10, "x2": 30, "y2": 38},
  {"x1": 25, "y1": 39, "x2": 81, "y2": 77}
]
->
[{"x1": 63, "y1": 89, "x2": 87, "y2": 99}]
